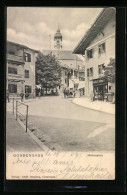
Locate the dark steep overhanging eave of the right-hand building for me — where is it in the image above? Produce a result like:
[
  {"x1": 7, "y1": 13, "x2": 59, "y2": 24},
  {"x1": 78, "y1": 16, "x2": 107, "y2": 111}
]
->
[{"x1": 73, "y1": 7, "x2": 115, "y2": 54}]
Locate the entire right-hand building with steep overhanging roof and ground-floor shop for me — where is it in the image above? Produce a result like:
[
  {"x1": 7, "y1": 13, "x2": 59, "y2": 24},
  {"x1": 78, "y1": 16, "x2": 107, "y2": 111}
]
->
[{"x1": 73, "y1": 8, "x2": 116, "y2": 100}]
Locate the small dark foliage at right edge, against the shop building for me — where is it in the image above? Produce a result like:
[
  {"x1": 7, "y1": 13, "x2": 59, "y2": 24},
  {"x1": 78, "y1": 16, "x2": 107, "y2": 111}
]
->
[{"x1": 104, "y1": 58, "x2": 115, "y2": 83}]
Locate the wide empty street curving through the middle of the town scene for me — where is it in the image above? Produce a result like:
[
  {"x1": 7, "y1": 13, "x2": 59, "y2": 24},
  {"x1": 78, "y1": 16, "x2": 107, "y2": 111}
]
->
[{"x1": 20, "y1": 97, "x2": 115, "y2": 151}]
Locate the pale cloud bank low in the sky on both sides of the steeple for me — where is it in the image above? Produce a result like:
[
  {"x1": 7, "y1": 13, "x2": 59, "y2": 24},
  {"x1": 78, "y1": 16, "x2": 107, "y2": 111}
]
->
[{"x1": 7, "y1": 22, "x2": 88, "y2": 50}]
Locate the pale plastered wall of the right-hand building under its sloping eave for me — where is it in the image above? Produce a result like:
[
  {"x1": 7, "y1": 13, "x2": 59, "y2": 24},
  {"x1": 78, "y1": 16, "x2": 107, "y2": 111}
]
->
[{"x1": 85, "y1": 18, "x2": 115, "y2": 96}]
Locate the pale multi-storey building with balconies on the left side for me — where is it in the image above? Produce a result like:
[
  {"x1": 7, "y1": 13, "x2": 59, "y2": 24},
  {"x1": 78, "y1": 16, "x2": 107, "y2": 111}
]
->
[{"x1": 6, "y1": 41, "x2": 38, "y2": 97}]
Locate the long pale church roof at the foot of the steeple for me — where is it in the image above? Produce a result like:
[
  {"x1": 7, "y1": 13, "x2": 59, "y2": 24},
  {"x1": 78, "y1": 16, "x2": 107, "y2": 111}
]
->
[{"x1": 42, "y1": 50, "x2": 83, "y2": 62}]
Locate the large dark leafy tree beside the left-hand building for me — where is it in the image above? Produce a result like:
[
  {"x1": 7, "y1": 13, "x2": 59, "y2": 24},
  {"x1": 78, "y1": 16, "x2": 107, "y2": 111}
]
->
[{"x1": 36, "y1": 52, "x2": 61, "y2": 93}]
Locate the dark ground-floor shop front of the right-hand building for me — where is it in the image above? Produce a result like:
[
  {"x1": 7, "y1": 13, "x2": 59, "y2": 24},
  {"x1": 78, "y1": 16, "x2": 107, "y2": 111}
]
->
[{"x1": 93, "y1": 78, "x2": 108, "y2": 101}]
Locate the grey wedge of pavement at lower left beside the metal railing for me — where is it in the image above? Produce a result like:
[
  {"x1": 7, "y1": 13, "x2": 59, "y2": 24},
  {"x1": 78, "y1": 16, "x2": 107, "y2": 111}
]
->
[{"x1": 6, "y1": 112, "x2": 42, "y2": 152}]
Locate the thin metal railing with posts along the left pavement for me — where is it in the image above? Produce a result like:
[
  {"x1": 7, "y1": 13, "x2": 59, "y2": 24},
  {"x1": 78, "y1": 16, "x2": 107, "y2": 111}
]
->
[{"x1": 13, "y1": 98, "x2": 29, "y2": 132}]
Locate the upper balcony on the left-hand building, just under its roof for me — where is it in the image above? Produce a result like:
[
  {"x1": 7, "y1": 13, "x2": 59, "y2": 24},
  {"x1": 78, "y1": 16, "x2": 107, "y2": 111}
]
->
[{"x1": 7, "y1": 54, "x2": 24, "y2": 65}]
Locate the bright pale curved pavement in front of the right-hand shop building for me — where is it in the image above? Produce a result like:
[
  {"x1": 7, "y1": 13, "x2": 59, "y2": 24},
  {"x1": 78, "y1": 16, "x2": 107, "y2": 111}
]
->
[{"x1": 72, "y1": 97, "x2": 115, "y2": 114}]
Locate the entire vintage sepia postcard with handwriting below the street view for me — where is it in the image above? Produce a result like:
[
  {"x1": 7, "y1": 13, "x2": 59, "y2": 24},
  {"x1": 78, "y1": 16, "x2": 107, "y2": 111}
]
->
[{"x1": 6, "y1": 7, "x2": 116, "y2": 180}]
